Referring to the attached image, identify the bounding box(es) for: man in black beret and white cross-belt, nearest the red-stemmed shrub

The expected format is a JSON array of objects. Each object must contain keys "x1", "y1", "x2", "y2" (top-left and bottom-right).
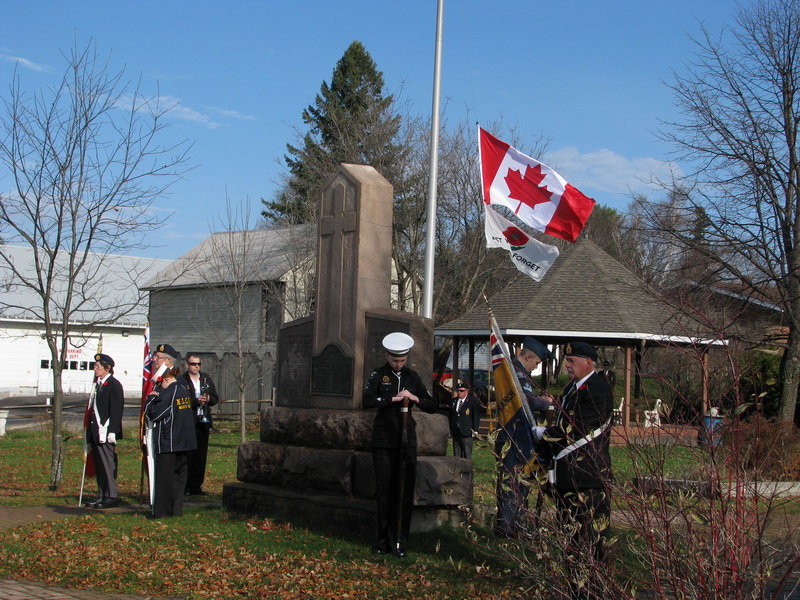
[{"x1": 534, "y1": 342, "x2": 614, "y2": 598}]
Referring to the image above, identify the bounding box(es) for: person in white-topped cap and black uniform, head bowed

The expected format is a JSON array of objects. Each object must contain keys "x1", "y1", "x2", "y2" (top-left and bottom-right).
[{"x1": 362, "y1": 332, "x2": 436, "y2": 558}]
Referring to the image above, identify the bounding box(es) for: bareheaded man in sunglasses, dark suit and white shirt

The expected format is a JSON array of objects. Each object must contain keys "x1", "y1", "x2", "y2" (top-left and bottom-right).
[{"x1": 179, "y1": 352, "x2": 219, "y2": 496}]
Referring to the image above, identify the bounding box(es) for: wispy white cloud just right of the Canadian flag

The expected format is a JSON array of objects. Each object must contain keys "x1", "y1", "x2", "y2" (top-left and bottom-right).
[{"x1": 545, "y1": 146, "x2": 681, "y2": 194}]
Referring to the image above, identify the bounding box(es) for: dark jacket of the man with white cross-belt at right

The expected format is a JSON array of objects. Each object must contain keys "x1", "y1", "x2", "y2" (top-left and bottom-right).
[{"x1": 537, "y1": 373, "x2": 614, "y2": 490}]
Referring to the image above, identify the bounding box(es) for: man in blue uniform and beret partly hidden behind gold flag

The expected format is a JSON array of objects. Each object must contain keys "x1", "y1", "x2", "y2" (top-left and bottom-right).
[{"x1": 494, "y1": 337, "x2": 553, "y2": 537}]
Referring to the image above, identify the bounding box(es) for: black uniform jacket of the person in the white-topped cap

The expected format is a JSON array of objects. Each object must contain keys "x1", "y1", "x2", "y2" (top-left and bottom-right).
[{"x1": 362, "y1": 363, "x2": 436, "y2": 448}]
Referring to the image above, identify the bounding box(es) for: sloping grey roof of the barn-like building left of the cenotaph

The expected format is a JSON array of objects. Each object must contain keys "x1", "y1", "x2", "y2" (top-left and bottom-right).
[{"x1": 142, "y1": 225, "x2": 315, "y2": 291}]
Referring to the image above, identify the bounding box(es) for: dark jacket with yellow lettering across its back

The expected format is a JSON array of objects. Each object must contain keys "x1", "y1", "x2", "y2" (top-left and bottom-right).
[{"x1": 145, "y1": 381, "x2": 197, "y2": 454}]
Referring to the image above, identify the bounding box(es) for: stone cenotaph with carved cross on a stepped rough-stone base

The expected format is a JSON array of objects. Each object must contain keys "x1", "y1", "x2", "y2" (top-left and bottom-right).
[{"x1": 222, "y1": 164, "x2": 473, "y2": 533}]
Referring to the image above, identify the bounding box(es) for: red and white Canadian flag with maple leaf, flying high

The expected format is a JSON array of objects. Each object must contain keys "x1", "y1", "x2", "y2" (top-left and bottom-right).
[{"x1": 478, "y1": 127, "x2": 595, "y2": 242}]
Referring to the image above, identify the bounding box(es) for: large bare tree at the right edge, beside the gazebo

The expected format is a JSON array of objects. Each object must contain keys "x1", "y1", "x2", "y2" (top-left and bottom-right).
[{"x1": 662, "y1": 0, "x2": 800, "y2": 421}]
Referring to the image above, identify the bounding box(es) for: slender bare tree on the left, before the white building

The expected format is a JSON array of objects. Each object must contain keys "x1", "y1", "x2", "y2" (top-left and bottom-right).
[{"x1": 0, "y1": 42, "x2": 188, "y2": 489}]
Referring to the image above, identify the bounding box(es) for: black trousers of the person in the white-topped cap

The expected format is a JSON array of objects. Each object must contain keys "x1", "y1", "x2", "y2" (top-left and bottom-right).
[{"x1": 372, "y1": 448, "x2": 417, "y2": 547}]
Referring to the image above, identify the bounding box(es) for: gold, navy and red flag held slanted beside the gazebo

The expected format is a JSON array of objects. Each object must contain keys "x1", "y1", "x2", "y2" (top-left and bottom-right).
[{"x1": 489, "y1": 312, "x2": 536, "y2": 472}]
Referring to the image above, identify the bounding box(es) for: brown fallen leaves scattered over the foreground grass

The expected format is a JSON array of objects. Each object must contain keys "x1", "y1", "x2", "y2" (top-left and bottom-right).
[{"x1": 0, "y1": 516, "x2": 520, "y2": 600}]
